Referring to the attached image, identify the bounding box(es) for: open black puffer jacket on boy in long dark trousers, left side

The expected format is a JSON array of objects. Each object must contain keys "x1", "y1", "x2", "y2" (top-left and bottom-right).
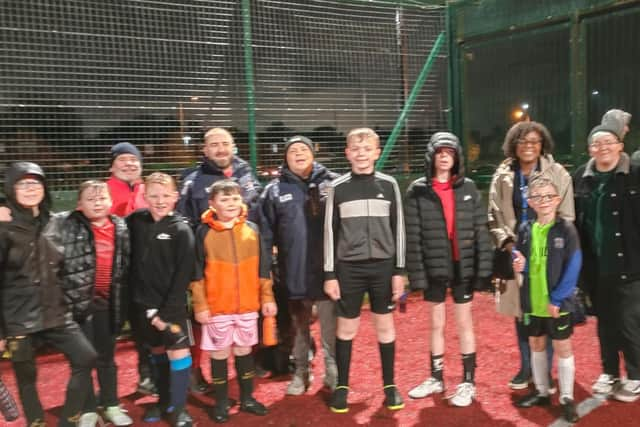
[{"x1": 47, "y1": 211, "x2": 130, "y2": 333}]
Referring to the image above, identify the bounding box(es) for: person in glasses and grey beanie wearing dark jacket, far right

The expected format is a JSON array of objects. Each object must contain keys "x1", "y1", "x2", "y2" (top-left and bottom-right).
[{"x1": 573, "y1": 125, "x2": 640, "y2": 402}]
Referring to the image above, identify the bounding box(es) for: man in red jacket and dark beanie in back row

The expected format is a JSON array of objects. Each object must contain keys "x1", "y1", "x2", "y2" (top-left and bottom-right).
[{"x1": 107, "y1": 142, "x2": 147, "y2": 216}]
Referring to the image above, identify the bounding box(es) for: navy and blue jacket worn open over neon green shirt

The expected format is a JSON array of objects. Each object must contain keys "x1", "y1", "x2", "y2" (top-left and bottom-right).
[{"x1": 517, "y1": 217, "x2": 582, "y2": 313}]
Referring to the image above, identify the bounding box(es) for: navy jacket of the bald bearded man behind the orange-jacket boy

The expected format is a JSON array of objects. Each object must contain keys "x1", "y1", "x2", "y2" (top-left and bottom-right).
[{"x1": 176, "y1": 156, "x2": 262, "y2": 226}]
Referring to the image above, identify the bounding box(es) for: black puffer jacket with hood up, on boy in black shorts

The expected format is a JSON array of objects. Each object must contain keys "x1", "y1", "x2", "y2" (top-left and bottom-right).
[{"x1": 404, "y1": 138, "x2": 493, "y2": 289}]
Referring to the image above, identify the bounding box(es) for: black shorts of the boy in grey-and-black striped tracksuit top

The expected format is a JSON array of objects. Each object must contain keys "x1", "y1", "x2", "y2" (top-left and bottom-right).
[{"x1": 336, "y1": 259, "x2": 395, "y2": 319}]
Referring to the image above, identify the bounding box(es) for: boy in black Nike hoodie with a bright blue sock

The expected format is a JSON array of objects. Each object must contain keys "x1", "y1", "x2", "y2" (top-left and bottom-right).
[{"x1": 127, "y1": 172, "x2": 195, "y2": 427}]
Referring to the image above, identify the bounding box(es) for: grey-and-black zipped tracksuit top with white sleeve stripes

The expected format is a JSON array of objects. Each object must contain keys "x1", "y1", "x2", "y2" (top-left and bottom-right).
[{"x1": 324, "y1": 172, "x2": 405, "y2": 280}]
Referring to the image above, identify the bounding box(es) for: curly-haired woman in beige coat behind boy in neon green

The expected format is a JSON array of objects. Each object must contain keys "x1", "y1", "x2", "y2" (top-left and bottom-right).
[{"x1": 489, "y1": 122, "x2": 575, "y2": 390}]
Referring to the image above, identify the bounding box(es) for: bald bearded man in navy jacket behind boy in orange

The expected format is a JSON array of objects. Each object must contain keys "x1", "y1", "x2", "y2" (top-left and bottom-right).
[{"x1": 177, "y1": 128, "x2": 262, "y2": 227}]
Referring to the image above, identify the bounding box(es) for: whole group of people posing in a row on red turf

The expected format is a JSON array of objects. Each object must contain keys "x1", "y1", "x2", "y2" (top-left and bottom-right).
[{"x1": 0, "y1": 110, "x2": 640, "y2": 427}]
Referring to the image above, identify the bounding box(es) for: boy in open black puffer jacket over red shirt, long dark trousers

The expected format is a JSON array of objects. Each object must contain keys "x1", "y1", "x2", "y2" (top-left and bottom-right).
[{"x1": 55, "y1": 181, "x2": 133, "y2": 426}]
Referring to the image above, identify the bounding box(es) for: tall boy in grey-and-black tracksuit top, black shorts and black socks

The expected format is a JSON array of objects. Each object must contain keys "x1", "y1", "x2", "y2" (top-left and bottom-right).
[{"x1": 324, "y1": 128, "x2": 405, "y2": 413}]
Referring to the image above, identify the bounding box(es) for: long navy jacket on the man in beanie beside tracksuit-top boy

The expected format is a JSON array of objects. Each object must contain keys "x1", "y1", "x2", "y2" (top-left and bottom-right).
[{"x1": 258, "y1": 162, "x2": 338, "y2": 300}]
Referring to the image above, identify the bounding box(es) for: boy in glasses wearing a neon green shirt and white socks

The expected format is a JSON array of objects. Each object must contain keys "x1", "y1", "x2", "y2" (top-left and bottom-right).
[{"x1": 513, "y1": 175, "x2": 582, "y2": 423}]
